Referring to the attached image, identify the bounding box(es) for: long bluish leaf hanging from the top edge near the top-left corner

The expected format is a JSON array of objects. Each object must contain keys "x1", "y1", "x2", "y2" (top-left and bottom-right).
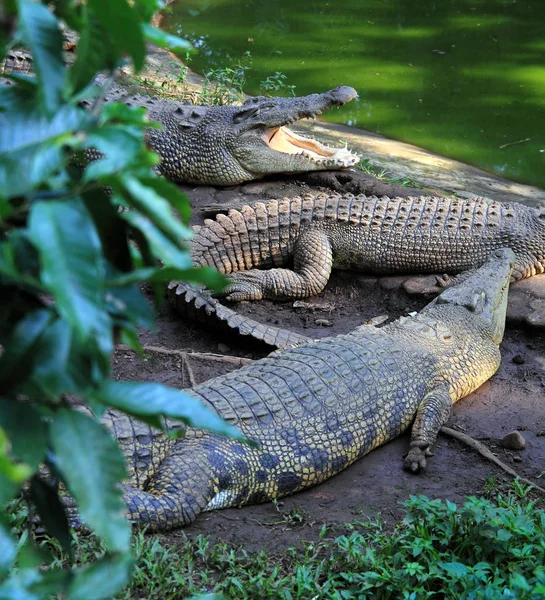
[{"x1": 17, "y1": 0, "x2": 66, "y2": 113}]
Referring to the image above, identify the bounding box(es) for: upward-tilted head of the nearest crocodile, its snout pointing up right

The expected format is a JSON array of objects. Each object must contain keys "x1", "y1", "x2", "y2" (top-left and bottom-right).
[{"x1": 432, "y1": 248, "x2": 516, "y2": 345}]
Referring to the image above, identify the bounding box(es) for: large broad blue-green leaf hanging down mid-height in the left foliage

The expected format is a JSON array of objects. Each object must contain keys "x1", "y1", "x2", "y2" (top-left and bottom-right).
[{"x1": 29, "y1": 198, "x2": 111, "y2": 344}]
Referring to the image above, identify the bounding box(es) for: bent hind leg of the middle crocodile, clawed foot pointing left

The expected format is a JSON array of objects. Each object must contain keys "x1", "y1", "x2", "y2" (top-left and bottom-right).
[{"x1": 223, "y1": 229, "x2": 333, "y2": 301}]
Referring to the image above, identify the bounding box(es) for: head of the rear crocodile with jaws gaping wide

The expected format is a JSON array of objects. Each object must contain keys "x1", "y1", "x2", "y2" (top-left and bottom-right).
[{"x1": 146, "y1": 86, "x2": 359, "y2": 185}]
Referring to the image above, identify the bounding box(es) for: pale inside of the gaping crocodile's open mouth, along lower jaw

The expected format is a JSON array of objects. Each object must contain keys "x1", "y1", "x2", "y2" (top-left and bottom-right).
[{"x1": 263, "y1": 127, "x2": 359, "y2": 167}]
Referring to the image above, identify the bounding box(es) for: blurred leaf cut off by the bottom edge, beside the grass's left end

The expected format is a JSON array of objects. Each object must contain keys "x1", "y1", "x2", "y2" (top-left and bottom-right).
[{"x1": 66, "y1": 555, "x2": 133, "y2": 600}]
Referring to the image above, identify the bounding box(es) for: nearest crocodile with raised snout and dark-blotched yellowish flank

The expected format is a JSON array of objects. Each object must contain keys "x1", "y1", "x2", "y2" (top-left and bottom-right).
[{"x1": 93, "y1": 248, "x2": 516, "y2": 531}]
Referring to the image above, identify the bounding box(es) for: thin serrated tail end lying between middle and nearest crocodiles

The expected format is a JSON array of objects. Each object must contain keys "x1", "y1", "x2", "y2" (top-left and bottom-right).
[{"x1": 167, "y1": 281, "x2": 311, "y2": 348}]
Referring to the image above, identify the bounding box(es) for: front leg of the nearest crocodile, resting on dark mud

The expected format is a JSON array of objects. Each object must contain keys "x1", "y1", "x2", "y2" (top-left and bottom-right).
[{"x1": 404, "y1": 387, "x2": 452, "y2": 473}]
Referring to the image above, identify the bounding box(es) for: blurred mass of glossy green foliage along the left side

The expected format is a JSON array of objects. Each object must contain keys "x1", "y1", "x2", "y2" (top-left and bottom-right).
[{"x1": 0, "y1": 0, "x2": 236, "y2": 600}]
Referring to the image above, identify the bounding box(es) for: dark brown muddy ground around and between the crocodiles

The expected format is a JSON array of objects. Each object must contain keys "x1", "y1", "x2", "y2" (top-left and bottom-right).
[{"x1": 110, "y1": 171, "x2": 545, "y2": 551}]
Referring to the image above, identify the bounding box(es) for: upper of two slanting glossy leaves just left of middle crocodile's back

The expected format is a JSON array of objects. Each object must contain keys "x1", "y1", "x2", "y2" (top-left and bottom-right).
[{"x1": 120, "y1": 175, "x2": 193, "y2": 245}]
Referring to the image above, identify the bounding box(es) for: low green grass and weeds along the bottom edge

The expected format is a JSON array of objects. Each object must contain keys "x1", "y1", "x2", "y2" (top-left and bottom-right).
[{"x1": 5, "y1": 480, "x2": 545, "y2": 600}]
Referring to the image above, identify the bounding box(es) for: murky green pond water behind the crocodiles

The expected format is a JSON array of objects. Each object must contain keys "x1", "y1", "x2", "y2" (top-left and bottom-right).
[{"x1": 164, "y1": 0, "x2": 545, "y2": 187}]
